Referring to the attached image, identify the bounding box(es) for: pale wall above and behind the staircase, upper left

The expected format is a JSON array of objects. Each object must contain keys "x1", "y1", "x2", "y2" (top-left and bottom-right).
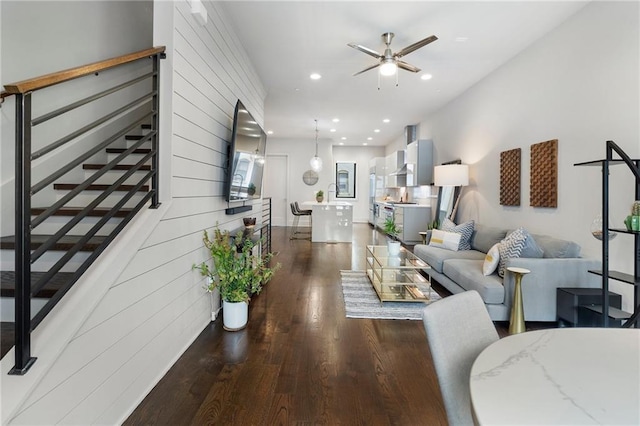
[{"x1": 0, "y1": 0, "x2": 153, "y2": 236}]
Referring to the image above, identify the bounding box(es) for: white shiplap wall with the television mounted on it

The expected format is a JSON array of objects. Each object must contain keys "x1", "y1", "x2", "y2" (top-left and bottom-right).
[{"x1": 6, "y1": 1, "x2": 266, "y2": 424}]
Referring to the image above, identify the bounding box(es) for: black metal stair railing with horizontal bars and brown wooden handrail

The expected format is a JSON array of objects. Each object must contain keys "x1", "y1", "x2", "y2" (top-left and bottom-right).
[{"x1": 0, "y1": 46, "x2": 165, "y2": 375}]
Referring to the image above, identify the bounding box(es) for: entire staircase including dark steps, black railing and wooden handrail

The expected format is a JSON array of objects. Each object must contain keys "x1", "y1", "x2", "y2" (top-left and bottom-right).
[{"x1": 0, "y1": 47, "x2": 164, "y2": 375}]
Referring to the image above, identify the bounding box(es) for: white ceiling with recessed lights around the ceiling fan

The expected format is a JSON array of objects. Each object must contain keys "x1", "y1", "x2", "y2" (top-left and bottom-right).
[{"x1": 223, "y1": 1, "x2": 587, "y2": 146}]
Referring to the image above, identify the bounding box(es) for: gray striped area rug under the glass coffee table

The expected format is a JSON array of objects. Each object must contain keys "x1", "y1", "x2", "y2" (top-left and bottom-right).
[{"x1": 340, "y1": 271, "x2": 441, "y2": 320}]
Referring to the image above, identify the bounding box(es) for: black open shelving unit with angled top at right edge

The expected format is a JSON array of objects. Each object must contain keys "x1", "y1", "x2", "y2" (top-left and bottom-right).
[{"x1": 574, "y1": 141, "x2": 640, "y2": 327}]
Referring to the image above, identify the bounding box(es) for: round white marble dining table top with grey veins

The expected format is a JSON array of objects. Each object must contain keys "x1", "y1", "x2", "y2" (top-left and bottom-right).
[{"x1": 469, "y1": 328, "x2": 640, "y2": 426}]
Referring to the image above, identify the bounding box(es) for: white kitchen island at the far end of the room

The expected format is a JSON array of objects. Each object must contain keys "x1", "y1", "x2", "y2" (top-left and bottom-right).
[{"x1": 302, "y1": 201, "x2": 353, "y2": 243}]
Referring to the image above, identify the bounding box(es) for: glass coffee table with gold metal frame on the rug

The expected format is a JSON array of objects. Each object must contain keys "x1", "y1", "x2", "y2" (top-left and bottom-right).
[{"x1": 366, "y1": 246, "x2": 432, "y2": 302}]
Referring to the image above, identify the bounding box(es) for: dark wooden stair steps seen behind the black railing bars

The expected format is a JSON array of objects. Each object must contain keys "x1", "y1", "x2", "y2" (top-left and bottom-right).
[{"x1": 0, "y1": 124, "x2": 151, "y2": 357}]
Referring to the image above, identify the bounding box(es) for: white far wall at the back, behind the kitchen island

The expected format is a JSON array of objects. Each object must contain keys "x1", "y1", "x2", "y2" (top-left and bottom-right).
[{"x1": 265, "y1": 137, "x2": 384, "y2": 225}]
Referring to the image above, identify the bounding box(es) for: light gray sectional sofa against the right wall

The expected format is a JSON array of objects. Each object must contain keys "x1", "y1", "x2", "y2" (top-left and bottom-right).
[{"x1": 413, "y1": 224, "x2": 602, "y2": 321}]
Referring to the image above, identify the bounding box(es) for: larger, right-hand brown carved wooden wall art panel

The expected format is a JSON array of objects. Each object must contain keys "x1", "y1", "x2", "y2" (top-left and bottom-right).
[{"x1": 529, "y1": 139, "x2": 558, "y2": 207}]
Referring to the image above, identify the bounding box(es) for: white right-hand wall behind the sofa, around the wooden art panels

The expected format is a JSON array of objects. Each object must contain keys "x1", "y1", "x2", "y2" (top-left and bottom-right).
[{"x1": 420, "y1": 2, "x2": 640, "y2": 310}]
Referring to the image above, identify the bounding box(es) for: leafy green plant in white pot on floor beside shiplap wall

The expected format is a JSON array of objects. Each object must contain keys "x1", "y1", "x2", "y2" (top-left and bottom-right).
[{"x1": 193, "y1": 228, "x2": 280, "y2": 331}]
